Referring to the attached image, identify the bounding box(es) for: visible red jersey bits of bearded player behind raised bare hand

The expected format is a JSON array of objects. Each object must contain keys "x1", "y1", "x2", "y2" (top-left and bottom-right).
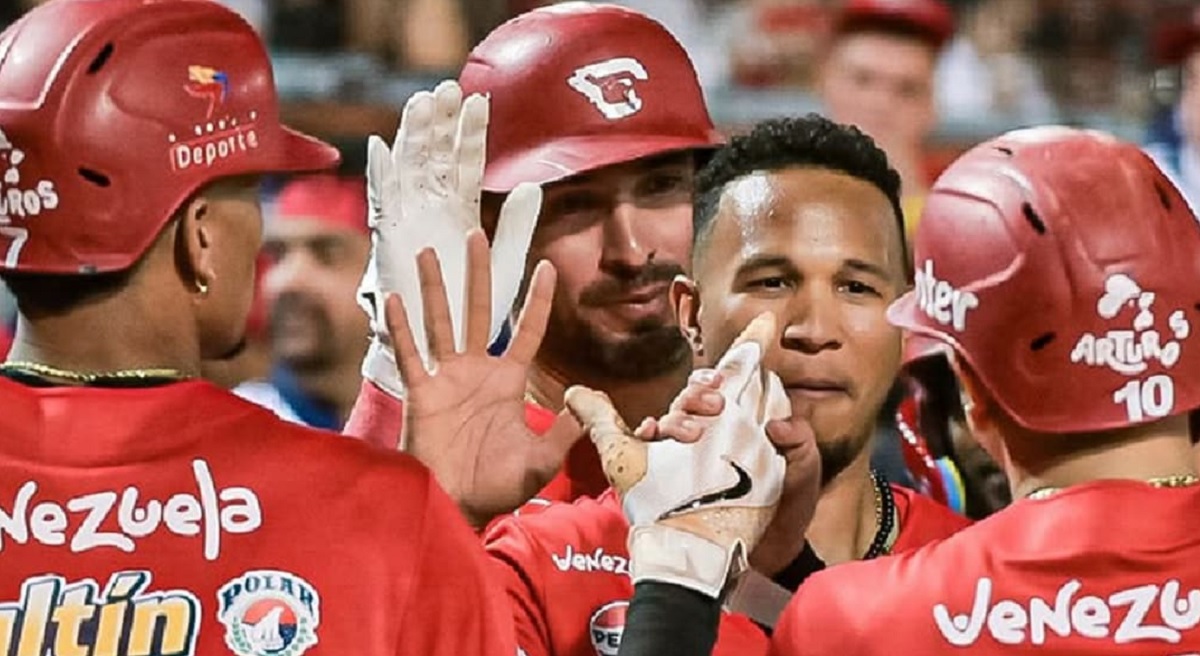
[{"x1": 342, "y1": 380, "x2": 608, "y2": 501}]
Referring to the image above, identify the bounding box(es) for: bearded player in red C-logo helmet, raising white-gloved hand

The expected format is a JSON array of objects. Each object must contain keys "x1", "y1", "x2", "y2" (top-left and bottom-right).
[{"x1": 346, "y1": 2, "x2": 721, "y2": 526}]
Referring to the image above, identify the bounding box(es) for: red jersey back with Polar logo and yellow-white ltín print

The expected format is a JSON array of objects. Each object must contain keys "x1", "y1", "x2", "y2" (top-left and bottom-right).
[{"x1": 0, "y1": 379, "x2": 516, "y2": 656}]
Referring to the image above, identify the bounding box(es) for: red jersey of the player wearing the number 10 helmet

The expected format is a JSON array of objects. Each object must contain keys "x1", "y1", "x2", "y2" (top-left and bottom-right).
[{"x1": 772, "y1": 481, "x2": 1200, "y2": 656}]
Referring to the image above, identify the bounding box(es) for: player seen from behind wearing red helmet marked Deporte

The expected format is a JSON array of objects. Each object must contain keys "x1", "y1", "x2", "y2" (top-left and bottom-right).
[{"x1": 0, "y1": 0, "x2": 516, "y2": 656}]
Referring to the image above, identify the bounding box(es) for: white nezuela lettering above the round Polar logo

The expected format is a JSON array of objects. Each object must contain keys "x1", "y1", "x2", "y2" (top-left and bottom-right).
[{"x1": 0, "y1": 459, "x2": 263, "y2": 560}]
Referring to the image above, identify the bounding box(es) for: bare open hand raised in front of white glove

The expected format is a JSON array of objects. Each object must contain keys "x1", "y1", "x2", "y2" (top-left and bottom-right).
[{"x1": 386, "y1": 230, "x2": 582, "y2": 528}]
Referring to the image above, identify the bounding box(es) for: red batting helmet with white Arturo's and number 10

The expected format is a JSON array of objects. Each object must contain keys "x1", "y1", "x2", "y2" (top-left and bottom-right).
[{"x1": 889, "y1": 127, "x2": 1200, "y2": 433}]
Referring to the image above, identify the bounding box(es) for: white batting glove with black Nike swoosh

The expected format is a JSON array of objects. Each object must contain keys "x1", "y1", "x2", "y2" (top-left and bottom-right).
[{"x1": 566, "y1": 314, "x2": 791, "y2": 598}]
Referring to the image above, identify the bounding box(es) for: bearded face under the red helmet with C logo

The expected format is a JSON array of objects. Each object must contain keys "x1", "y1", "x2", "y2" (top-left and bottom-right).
[{"x1": 527, "y1": 152, "x2": 695, "y2": 380}]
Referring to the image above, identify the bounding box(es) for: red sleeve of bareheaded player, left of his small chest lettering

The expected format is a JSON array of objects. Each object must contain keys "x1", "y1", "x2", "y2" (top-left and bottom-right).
[{"x1": 484, "y1": 522, "x2": 551, "y2": 656}]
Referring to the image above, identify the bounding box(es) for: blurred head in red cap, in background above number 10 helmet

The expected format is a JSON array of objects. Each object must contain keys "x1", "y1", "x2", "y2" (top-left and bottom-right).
[{"x1": 818, "y1": 0, "x2": 954, "y2": 234}]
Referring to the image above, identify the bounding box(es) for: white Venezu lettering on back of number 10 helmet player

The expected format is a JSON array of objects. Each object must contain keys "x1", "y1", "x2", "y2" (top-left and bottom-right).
[{"x1": 934, "y1": 577, "x2": 1200, "y2": 646}]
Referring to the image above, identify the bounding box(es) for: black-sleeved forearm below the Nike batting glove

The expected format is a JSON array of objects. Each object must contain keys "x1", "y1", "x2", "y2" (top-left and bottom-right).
[{"x1": 618, "y1": 580, "x2": 721, "y2": 656}]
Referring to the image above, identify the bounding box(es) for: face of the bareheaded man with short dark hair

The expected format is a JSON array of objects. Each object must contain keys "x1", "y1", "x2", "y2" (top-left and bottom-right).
[{"x1": 678, "y1": 168, "x2": 905, "y2": 480}]
